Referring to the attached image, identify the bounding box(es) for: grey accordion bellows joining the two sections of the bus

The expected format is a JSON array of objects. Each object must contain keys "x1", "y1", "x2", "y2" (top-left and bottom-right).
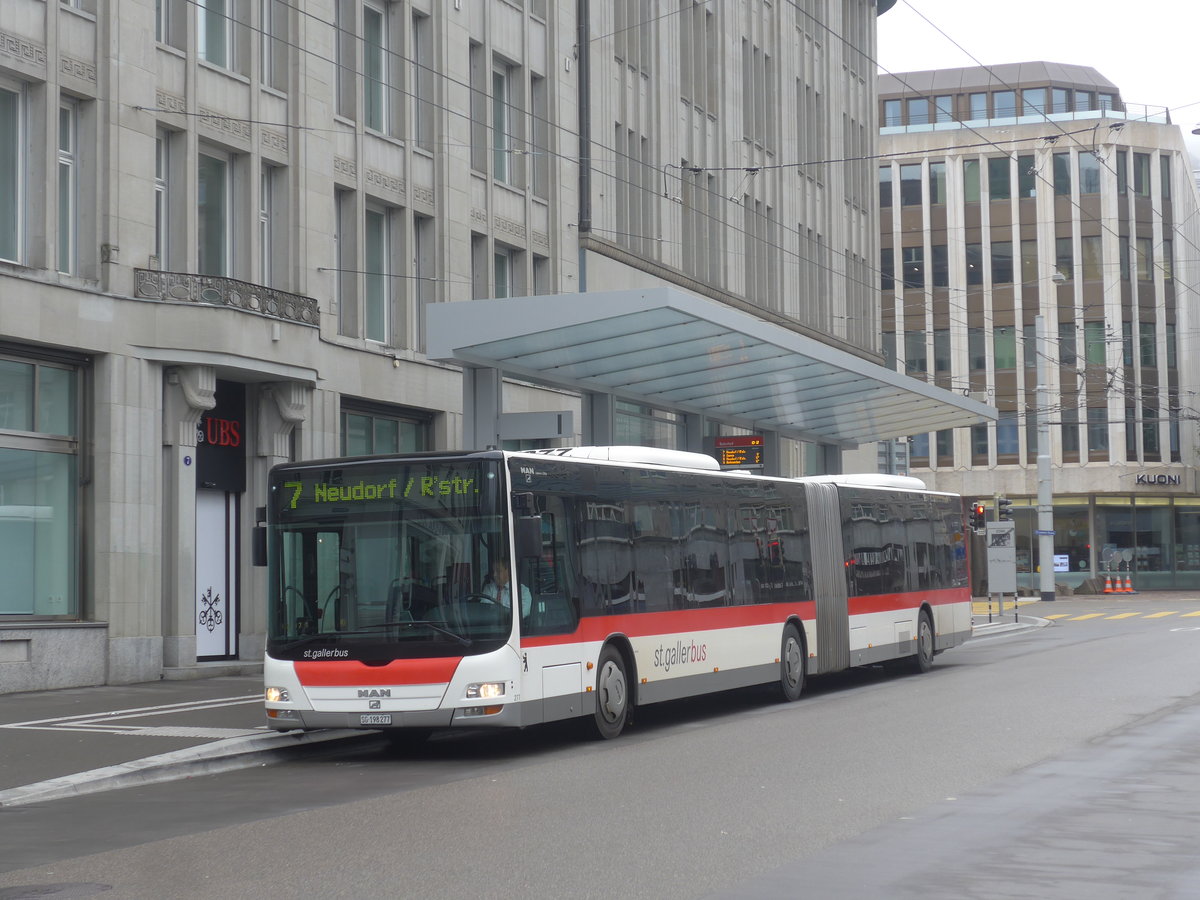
[{"x1": 804, "y1": 481, "x2": 850, "y2": 674}]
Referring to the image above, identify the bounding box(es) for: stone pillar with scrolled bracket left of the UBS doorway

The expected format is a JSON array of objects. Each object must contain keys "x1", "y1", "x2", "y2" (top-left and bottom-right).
[{"x1": 162, "y1": 366, "x2": 217, "y2": 667}]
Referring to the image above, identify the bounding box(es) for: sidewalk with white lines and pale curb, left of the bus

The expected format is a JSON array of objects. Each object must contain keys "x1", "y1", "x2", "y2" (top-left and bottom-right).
[{"x1": 0, "y1": 674, "x2": 362, "y2": 806}]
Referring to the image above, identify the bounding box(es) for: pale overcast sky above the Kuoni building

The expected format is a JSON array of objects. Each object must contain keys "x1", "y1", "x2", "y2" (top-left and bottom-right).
[{"x1": 878, "y1": 0, "x2": 1200, "y2": 166}]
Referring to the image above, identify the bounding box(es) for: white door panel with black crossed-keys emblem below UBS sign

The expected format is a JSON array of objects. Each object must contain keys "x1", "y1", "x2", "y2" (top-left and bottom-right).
[{"x1": 196, "y1": 491, "x2": 239, "y2": 660}]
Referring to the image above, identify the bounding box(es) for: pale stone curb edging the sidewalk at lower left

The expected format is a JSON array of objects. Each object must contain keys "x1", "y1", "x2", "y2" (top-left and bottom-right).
[{"x1": 0, "y1": 728, "x2": 364, "y2": 809}]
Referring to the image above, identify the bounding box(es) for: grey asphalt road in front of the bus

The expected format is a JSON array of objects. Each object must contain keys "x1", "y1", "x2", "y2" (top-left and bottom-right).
[{"x1": 0, "y1": 600, "x2": 1200, "y2": 900}]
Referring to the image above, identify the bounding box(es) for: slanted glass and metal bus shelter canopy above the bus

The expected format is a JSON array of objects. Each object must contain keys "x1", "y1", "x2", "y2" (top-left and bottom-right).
[{"x1": 426, "y1": 287, "x2": 996, "y2": 446}]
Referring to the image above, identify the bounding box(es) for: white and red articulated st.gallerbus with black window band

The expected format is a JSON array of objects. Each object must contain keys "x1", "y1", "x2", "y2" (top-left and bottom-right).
[{"x1": 264, "y1": 448, "x2": 971, "y2": 738}]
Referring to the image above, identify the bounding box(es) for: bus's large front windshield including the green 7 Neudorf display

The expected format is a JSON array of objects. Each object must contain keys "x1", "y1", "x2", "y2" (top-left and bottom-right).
[{"x1": 268, "y1": 458, "x2": 512, "y2": 661}]
